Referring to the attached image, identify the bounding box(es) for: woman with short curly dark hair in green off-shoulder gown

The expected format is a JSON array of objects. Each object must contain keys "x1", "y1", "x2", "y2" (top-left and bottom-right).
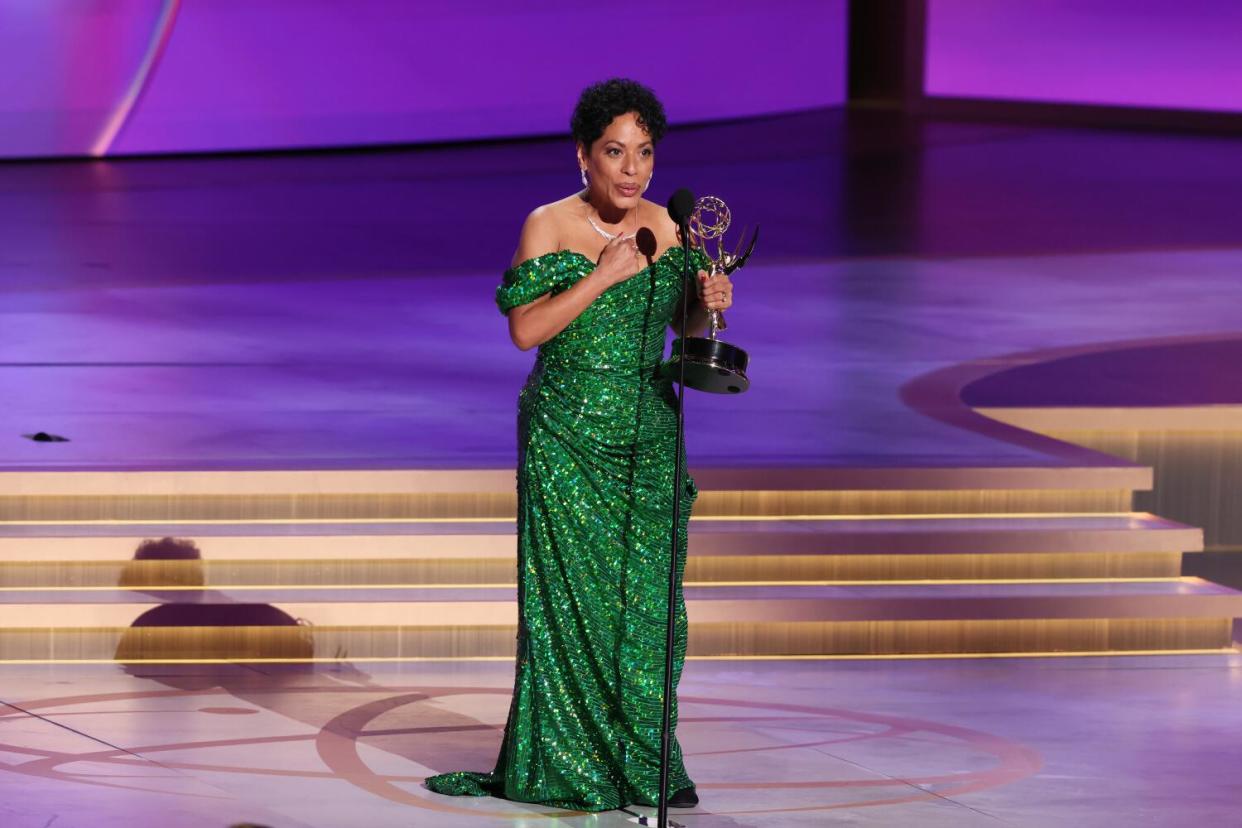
[{"x1": 426, "y1": 74, "x2": 733, "y2": 811}]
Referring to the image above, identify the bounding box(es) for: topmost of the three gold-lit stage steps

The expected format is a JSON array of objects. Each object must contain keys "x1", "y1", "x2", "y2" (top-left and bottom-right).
[{"x1": 0, "y1": 466, "x2": 1151, "y2": 524}]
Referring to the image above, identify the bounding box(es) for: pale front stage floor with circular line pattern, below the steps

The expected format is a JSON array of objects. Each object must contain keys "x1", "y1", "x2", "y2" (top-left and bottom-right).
[{"x1": 0, "y1": 655, "x2": 1242, "y2": 828}]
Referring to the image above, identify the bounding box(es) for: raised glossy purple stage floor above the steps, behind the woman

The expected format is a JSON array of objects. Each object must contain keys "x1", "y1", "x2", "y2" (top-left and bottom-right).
[{"x1": 7, "y1": 110, "x2": 1242, "y2": 470}]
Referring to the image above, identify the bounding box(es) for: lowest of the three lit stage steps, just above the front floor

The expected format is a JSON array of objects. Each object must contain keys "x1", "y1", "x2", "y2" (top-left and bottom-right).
[{"x1": 0, "y1": 578, "x2": 1242, "y2": 660}]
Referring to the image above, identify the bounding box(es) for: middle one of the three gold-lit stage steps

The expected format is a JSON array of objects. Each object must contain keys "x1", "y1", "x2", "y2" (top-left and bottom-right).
[{"x1": 0, "y1": 514, "x2": 1202, "y2": 588}]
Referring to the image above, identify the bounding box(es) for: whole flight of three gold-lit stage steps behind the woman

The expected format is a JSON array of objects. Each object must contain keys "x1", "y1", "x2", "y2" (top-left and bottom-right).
[{"x1": 0, "y1": 468, "x2": 1242, "y2": 662}]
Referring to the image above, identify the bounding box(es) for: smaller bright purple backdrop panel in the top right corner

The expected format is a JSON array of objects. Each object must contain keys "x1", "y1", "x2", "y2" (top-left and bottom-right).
[{"x1": 924, "y1": 0, "x2": 1242, "y2": 112}]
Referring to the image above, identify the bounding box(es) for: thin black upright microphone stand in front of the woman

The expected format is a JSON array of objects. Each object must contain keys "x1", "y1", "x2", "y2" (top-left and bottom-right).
[{"x1": 638, "y1": 196, "x2": 693, "y2": 828}]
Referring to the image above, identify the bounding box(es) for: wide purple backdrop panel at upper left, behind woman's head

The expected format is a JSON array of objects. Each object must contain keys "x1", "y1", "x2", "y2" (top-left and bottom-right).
[{"x1": 0, "y1": 0, "x2": 846, "y2": 158}]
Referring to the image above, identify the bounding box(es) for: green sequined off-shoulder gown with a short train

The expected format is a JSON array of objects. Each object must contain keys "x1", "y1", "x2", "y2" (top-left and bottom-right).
[{"x1": 426, "y1": 247, "x2": 705, "y2": 811}]
